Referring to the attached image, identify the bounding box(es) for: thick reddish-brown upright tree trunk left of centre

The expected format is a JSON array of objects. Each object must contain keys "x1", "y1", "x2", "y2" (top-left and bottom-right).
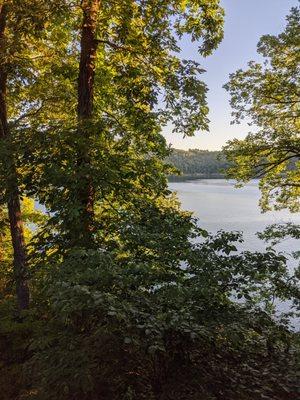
[{"x1": 77, "y1": 0, "x2": 100, "y2": 245}]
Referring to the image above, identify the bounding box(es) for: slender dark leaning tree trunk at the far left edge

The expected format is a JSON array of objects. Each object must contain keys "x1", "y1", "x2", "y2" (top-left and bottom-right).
[{"x1": 0, "y1": 4, "x2": 29, "y2": 310}]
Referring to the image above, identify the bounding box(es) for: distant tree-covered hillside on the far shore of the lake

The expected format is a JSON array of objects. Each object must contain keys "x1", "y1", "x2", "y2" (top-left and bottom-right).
[{"x1": 168, "y1": 149, "x2": 229, "y2": 180}]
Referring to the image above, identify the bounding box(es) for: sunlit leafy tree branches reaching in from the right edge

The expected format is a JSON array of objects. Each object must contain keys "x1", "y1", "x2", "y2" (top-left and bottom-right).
[{"x1": 224, "y1": 7, "x2": 300, "y2": 212}]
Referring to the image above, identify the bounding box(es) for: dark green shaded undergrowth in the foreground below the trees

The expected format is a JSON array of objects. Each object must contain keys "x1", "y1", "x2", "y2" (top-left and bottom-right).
[{"x1": 26, "y1": 231, "x2": 299, "y2": 400}]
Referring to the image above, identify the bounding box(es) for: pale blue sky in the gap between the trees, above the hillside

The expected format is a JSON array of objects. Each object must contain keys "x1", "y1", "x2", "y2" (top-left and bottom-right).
[{"x1": 164, "y1": 0, "x2": 299, "y2": 150}]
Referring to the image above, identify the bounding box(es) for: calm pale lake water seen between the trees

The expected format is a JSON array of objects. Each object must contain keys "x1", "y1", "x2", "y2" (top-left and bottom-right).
[{"x1": 169, "y1": 179, "x2": 300, "y2": 252}]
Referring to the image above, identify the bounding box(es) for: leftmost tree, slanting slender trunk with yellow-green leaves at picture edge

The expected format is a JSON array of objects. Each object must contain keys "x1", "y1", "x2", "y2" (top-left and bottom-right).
[{"x1": 0, "y1": 0, "x2": 69, "y2": 310}]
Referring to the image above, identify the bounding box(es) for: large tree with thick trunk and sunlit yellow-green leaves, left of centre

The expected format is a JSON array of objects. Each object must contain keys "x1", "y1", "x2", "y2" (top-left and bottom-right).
[{"x1": 20, "y1": 0, "x2": 223, "y2": 249}]
